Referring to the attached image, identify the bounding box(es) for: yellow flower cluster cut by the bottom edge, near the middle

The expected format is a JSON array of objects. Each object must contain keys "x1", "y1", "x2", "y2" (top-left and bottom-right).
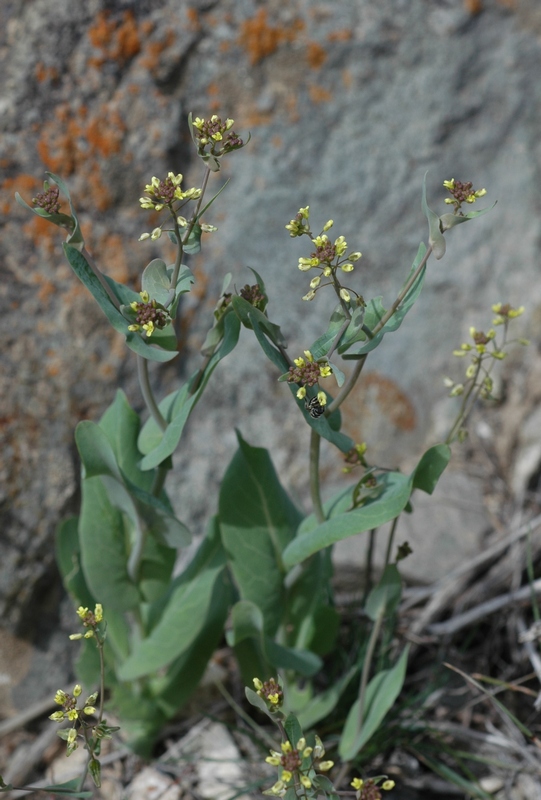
[{"x1": 263, "y1": 736, "x2": 334, "y2": 797}]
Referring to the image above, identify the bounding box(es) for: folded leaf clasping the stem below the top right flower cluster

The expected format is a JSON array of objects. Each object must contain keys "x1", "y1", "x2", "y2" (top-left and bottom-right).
[{"x1": 338, "y1": 242, "x2": 426, "y2": 359}]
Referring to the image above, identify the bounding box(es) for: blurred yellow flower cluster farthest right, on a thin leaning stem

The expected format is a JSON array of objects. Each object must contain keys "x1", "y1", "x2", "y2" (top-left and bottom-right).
[{"x1": 444, "y1": 303, "x2": 528, "y2": 400}]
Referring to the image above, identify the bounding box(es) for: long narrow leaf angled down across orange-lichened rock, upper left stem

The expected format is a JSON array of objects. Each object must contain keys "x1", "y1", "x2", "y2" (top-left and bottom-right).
[{"x1": 64, "y1": 244, "x2": 176, "y2": 362}]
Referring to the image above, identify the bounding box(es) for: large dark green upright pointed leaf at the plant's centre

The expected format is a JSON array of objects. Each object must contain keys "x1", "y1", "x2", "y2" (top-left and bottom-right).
[{"x1": 219, "y1": 433, "x2": 302, "y2": 635}]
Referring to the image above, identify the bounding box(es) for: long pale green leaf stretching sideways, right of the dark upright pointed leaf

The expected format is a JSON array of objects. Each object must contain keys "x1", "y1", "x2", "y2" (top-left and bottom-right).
[{"x1": 283, "y1": 472, "x2": 412, "y2": 569}]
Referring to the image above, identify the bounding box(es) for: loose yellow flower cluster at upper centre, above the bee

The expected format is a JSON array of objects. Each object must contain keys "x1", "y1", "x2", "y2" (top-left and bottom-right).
[{"x1": 286, "y1": 206, "x2": 362, "y2": 303}]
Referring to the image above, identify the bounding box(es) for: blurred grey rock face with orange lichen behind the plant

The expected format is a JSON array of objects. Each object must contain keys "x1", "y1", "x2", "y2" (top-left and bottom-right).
[{"x1": 0, "y1": 0, "x2": 541, "y2": 713}]
